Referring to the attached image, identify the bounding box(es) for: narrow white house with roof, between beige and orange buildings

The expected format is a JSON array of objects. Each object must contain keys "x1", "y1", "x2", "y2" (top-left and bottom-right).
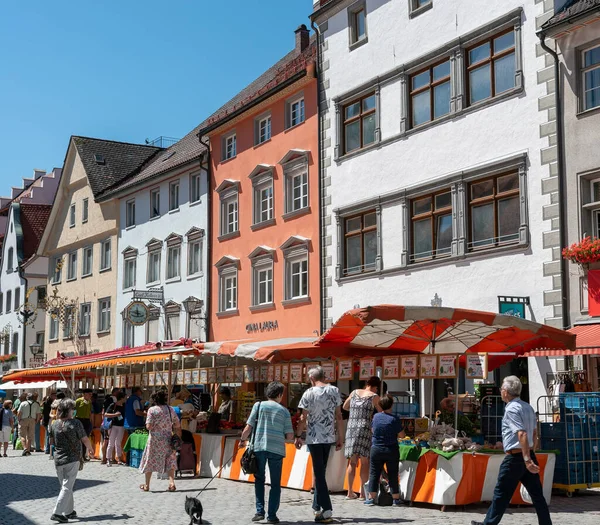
[{"x1": 106, "y1": 134, "x2": 208, "y2": 347}]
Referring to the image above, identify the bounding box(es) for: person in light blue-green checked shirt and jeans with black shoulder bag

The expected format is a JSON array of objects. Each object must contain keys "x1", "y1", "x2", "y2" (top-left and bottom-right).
[{"x1": 240, "y1": 381, "x2": 294, "y2": 523}]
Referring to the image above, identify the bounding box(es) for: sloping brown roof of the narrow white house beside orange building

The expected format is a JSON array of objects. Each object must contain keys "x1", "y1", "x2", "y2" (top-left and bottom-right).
[{"x1": 97, "y1": 123, "x2": 206, "y2": 202}]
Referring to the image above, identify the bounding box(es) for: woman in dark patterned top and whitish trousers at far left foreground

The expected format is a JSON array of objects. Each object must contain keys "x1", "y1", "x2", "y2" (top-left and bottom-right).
[{"x1": 50, "y1": 399, "x2": 94, "y2": 523}]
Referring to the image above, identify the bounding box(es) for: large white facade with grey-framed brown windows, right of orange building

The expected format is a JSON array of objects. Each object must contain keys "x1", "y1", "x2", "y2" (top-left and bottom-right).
[{"x1": 312, "y1": 0, "x2": 561, "y2": 406}]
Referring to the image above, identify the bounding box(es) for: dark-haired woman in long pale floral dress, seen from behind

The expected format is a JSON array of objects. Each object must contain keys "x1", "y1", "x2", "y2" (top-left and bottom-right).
[{"x1": 140, "y1": 391, "x2": 181, "y2": 492}]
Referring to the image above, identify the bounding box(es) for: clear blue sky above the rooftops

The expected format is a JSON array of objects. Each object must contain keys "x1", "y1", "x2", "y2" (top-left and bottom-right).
[{"x1": 0, "y1": 0, "x2": 312, "y2": 195}]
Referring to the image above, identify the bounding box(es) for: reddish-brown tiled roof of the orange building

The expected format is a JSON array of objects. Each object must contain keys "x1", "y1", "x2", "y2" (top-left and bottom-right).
[{"x1": 199, "y1": 34, "x2": 317, "y2": 135}]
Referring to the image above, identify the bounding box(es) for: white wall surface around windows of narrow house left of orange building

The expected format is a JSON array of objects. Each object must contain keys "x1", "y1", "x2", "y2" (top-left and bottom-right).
[{"x1": 116, "y1": 167, "x2": 208, "y2": 346}]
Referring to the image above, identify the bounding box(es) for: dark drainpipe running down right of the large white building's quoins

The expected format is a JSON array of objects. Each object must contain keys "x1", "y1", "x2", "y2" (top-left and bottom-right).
[{"x1": 538, "y1": 32, "x2": 571, "y2": 330}]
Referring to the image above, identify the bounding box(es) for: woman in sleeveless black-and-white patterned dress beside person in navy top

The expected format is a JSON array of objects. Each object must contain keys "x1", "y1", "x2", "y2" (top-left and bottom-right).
[{"x1": 344, "y1": 376, "x2": 381, "y2": 500}]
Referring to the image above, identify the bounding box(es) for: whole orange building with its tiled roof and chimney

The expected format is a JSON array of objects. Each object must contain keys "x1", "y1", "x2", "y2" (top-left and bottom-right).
[{"x1": 200, "y1": 27, "x2": 321, "y2": 341}]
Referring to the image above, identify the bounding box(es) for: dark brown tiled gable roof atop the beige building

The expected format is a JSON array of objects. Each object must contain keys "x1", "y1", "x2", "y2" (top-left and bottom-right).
[{"x1": 72, "y1": 136, "x2": 163, "y2": 200}]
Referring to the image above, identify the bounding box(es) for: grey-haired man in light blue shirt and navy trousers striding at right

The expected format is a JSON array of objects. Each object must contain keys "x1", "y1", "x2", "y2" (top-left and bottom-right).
[{"x1": 471, "y1": 376, "x2": 552, "y2": 525}]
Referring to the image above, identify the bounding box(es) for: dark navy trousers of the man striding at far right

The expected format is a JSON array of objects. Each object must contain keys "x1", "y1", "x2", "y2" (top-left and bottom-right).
[{"x1": 483, "y1": 451, "x2": 552, "y2": 525}]
